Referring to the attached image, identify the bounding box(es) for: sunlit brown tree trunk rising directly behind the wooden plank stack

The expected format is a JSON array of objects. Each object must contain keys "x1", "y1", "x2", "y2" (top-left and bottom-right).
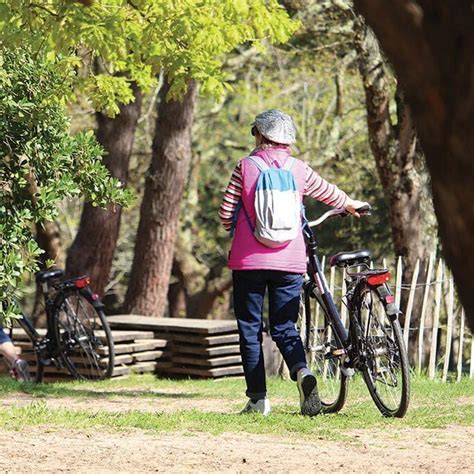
[{"x1": 125, "y1": 80, "x2": 197, "y2": 317}]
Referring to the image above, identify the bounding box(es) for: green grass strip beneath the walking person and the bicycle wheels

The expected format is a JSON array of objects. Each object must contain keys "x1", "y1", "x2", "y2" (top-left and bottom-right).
[{"x1": 0, "y1": 375, "x2": 474, "y2": 440}]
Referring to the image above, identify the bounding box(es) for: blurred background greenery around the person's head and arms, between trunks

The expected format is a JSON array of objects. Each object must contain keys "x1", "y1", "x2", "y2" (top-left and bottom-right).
[{"x1": 191, "y1": 44, "x2": 391, "y2": 274}]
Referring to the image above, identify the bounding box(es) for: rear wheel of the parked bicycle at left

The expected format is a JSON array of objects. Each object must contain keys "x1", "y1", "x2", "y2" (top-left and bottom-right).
[{"x1": 55, "y1": 290, "x2": 114, "y2": 380}]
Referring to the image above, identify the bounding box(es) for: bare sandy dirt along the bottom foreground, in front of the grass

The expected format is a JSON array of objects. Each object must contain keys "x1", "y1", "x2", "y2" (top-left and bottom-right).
[{"x1": 0, "y1": 427, "x2": 474, "y2": 473}]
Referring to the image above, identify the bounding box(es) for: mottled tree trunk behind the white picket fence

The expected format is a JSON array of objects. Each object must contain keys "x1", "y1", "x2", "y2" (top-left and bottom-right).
[{"x1": 355, "y1": 21, "x2": 436, "y2": 362}]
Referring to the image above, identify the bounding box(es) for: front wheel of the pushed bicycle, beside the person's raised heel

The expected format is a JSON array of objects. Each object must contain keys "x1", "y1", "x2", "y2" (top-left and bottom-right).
[{"x1": 301, "y1": 290, "x2": 348, "y2": 413}]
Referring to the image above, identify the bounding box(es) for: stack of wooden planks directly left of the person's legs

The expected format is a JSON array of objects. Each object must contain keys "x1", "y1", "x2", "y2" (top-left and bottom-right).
[{"x1": 108, "y1": 315, "x2": 243, "y2": 378}]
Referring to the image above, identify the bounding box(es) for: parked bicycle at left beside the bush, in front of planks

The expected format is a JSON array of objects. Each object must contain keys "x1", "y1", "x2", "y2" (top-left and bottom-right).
[{"x1": 17, "y1": 270, "x2": 115, "y2": 383}]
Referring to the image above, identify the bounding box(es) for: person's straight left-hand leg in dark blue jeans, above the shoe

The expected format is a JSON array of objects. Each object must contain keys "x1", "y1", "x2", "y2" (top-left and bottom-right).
[{"x1": 232, "y1": 270, "x2": 267, "y2": 400}]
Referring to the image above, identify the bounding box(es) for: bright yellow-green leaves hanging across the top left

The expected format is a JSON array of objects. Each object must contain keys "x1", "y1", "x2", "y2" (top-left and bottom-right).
[{"x1": 0, "y1": 0, "x2": 299, "y2": 116}]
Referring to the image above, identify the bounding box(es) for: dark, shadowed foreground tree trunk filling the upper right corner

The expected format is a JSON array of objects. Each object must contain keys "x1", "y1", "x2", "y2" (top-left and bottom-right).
[{"x1": 354, "y1": 0, "x2": 474, "y2": 331}]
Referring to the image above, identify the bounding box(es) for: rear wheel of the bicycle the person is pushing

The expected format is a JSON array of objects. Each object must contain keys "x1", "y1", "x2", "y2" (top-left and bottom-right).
[{"x1": 359, "y1": 288, "x2": 410, "y2": 418}]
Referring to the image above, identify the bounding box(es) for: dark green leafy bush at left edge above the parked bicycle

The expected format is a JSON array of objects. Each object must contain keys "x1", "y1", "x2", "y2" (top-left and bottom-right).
[{"x1": 0, "y1": 48, "x2": 131, "y2": 320}]
